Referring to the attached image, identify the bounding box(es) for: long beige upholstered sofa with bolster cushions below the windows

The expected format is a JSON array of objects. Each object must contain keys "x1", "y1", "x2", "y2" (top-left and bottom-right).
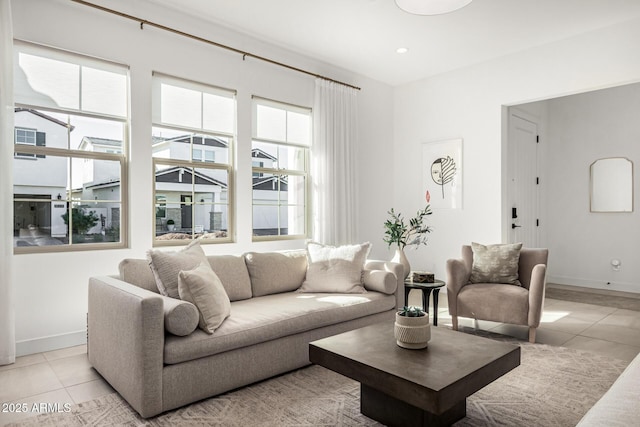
[{"x1": 88, "y1": 251, "x2": 404, "y2": 418}]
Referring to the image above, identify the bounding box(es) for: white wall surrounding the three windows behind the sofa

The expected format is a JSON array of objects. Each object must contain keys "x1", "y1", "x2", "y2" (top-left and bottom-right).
[{"x1": 12, "y1": 0, "x2": 393, "y2": 354}]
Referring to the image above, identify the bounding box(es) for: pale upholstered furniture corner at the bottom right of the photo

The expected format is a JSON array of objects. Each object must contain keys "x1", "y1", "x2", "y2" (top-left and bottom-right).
[{"x1": 578, "y1": 355, "x2": 640, "y2": 427}]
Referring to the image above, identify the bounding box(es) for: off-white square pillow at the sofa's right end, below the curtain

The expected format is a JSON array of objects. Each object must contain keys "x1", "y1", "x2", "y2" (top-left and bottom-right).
[{"x1": 298, "y1": 242, "x2": 371, "y2": 294}]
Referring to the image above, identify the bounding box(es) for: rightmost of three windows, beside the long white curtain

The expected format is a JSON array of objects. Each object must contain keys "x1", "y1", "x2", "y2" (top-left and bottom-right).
[{"x1": 251, "y1": 97, "x2": 311, "y2": 240}]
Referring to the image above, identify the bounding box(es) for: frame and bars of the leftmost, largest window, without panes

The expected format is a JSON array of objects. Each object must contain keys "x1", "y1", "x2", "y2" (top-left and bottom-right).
[{"x1": 13, "y1": 40, "x2": 131, "y2": 254}]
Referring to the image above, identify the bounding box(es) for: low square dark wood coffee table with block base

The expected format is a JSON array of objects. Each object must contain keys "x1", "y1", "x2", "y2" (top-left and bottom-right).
[{"x1": 309, "y1": 322, "x2": 520, "y2": 426}]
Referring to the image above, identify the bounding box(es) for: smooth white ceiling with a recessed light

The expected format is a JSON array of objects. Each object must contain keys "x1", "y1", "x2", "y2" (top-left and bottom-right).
[{"x1": 149, "y1": 0, "x2": 640, "y2": 86}]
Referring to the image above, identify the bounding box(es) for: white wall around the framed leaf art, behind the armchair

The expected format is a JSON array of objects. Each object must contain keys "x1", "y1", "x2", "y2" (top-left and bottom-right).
[{"x1": 388, "y1": 15, "x2": 640, "y2": 280}]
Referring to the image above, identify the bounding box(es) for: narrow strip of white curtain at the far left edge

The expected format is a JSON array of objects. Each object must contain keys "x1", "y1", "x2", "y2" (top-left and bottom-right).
[{"x1": 0, "y1": 0, "x2": 16, "y2": 365}]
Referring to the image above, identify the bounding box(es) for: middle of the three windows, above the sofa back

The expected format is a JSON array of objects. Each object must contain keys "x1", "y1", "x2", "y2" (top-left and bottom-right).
[{"x1": 152, "y1": 73, "x2": 236, "y2": 245}]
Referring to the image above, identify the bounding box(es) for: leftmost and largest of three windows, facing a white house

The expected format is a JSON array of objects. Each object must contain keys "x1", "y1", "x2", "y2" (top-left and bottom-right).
[{"x1": 13, "y1": 42, "x2": 128, "y2": 253}]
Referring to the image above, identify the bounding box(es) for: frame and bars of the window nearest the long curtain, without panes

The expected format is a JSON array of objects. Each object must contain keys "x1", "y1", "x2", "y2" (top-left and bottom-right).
[{"x1": 251, "y1": 95, "x2": 313, "y2": 242}]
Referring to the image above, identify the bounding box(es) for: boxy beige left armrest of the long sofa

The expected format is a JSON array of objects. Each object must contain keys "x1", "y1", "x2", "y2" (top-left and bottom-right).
[{"x1": 87, "y1": 276, "x2": 164, "y2": 418}]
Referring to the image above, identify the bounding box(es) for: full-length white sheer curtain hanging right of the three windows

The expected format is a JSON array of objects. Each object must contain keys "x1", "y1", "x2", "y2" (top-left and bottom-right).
[{"x1": 311, "y1": 79, "x2": 358, "y2": 245}]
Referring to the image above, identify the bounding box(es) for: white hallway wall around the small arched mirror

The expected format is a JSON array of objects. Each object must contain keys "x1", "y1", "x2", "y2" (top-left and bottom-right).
[{"x1": 546, "y1": 84, "x2": 640, "y2": 292}]
